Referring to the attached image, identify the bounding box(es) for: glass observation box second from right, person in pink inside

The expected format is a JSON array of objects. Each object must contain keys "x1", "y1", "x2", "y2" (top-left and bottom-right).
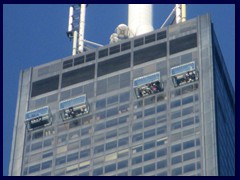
[{"x1": 133, "y1": 72, "x2": 164, "y2": 98}]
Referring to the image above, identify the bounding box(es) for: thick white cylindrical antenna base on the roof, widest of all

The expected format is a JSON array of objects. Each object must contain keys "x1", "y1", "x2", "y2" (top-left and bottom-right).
[{"x1": 128, "y1": 4, "x2": 153, "y2": 37}]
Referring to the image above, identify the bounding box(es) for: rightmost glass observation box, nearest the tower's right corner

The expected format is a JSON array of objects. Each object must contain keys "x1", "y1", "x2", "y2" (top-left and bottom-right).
[{"x1": 171, "y1": 62, "x2": 199, "y2": 87}]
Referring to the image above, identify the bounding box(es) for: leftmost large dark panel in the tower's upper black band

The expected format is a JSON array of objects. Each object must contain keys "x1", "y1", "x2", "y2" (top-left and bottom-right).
[{"x1": 31, "y1": 75, "x2": 59, "y2": 97}]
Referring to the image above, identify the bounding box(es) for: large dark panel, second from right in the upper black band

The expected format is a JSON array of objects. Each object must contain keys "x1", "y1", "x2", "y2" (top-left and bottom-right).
[{"x1": 133, "y1": 43, "x2": 167, "y2": 65}]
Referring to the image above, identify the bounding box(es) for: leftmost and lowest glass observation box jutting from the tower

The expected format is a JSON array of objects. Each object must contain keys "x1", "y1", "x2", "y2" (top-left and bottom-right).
[{"x1": 25, "y1": 106, "x2": 52, "y2": 131}]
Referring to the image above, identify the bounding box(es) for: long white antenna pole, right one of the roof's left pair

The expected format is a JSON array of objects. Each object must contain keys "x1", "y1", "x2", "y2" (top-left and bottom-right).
[{"x1": 78, "y1": 4, "x2": 87, "y2": 53}]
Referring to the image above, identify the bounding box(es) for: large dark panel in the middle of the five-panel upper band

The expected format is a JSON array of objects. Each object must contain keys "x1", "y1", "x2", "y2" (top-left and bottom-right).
[{"x1": 98, "y1": 53, "x2": 131, "y2": 77}]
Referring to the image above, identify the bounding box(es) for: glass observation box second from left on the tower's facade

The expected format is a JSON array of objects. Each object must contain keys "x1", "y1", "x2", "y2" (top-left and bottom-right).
[{"x1": 59, "y1": 95, "x2": 89, "y2": 121}]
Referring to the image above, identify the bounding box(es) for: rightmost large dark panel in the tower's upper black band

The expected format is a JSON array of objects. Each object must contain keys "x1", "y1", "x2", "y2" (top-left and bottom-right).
[{"x1": 170, "y1": 33, "x2": 197, "y2": 54}]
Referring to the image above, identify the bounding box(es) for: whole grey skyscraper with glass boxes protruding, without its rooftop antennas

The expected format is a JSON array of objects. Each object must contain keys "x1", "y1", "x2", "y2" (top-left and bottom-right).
[{"x1": 9, "y1": 15, "x2": 235, "y2": 176}]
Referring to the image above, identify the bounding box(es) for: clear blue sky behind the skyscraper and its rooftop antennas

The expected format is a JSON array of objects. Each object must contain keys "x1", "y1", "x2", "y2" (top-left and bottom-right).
[{"x1": 3, "y1": 4, "x2": 235, "y2": 175}]
